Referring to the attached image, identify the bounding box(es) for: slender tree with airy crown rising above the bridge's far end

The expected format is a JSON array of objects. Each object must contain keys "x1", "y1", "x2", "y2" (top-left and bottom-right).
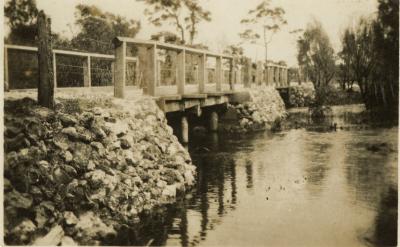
[{"x1": 239, "y1": 0, "x2": 287, "y2": 61}]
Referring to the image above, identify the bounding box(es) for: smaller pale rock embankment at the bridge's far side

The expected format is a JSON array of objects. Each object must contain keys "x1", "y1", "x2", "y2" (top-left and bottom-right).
[{"x1": 222, "y1": 86, "x2": 286, "y2": 133}]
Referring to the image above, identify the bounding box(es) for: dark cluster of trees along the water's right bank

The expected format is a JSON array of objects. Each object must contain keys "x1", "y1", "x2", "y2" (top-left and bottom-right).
[{"x1": 297, "y1": 0, "x2": 399, "y2": 114}]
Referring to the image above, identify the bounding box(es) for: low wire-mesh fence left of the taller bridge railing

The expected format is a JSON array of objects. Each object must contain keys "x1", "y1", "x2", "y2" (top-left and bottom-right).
[{"x1": 4, "y1": 45, "x2": 138, "y2": 89}]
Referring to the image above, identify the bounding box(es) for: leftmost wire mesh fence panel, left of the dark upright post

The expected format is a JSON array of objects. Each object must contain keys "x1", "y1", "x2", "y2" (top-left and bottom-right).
[{"x1": 8, "y1": 49, "x2": 39, "y2": 89}]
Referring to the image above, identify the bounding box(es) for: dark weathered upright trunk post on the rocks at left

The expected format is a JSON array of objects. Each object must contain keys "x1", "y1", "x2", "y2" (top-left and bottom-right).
[{"x1": 37, "y1": 10, "x2": 54, "y2": 108}]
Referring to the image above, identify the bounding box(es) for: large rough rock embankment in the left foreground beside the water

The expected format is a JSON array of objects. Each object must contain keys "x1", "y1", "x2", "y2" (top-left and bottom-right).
[{"x1": 4, "y1": 95, "x2": 195, "y2": 245}]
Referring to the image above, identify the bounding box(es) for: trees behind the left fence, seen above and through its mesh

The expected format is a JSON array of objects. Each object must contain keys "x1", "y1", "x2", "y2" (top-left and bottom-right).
[{"x1": 4, "y1": 0, "x2": 211, "y2": 89}]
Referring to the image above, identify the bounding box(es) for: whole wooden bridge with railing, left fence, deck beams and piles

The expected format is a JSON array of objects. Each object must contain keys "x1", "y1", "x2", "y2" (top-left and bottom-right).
[{"x1": 4, "y1": 37, "x2": 289, "y2": 141}]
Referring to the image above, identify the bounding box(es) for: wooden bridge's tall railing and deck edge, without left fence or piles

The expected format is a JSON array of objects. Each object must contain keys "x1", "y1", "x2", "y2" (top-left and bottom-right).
[{"x1": 114, "y1": 37, "x2": 288, "y2": 112}]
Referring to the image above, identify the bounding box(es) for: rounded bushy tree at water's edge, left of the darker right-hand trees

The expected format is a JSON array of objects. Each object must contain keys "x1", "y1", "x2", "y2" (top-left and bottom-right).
[{"x1": 297, "y1": 21, "x2": 335, "y2": 105}]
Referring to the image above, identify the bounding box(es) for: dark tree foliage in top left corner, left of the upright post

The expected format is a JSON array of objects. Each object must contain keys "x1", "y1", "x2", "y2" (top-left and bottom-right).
[{"x1": 4, "y1": 0, "x2": 38, "y2": 45}]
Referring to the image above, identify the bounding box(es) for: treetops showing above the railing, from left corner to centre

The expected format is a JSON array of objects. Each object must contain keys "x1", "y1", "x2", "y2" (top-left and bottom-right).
[{"x1": 4, "y1": 0, "x2": 211, "y2": 53}]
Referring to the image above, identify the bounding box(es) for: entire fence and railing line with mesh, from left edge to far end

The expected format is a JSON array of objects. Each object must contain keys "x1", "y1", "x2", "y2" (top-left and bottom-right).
[{"x1": 4, "y1": 41, "x2": 288, "y2": 95}]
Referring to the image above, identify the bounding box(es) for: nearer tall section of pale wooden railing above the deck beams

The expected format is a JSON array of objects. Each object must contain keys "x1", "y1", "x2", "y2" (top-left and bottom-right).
[{"x1": 114, "y1": 37, "x2": 238, "y2": 97}]
